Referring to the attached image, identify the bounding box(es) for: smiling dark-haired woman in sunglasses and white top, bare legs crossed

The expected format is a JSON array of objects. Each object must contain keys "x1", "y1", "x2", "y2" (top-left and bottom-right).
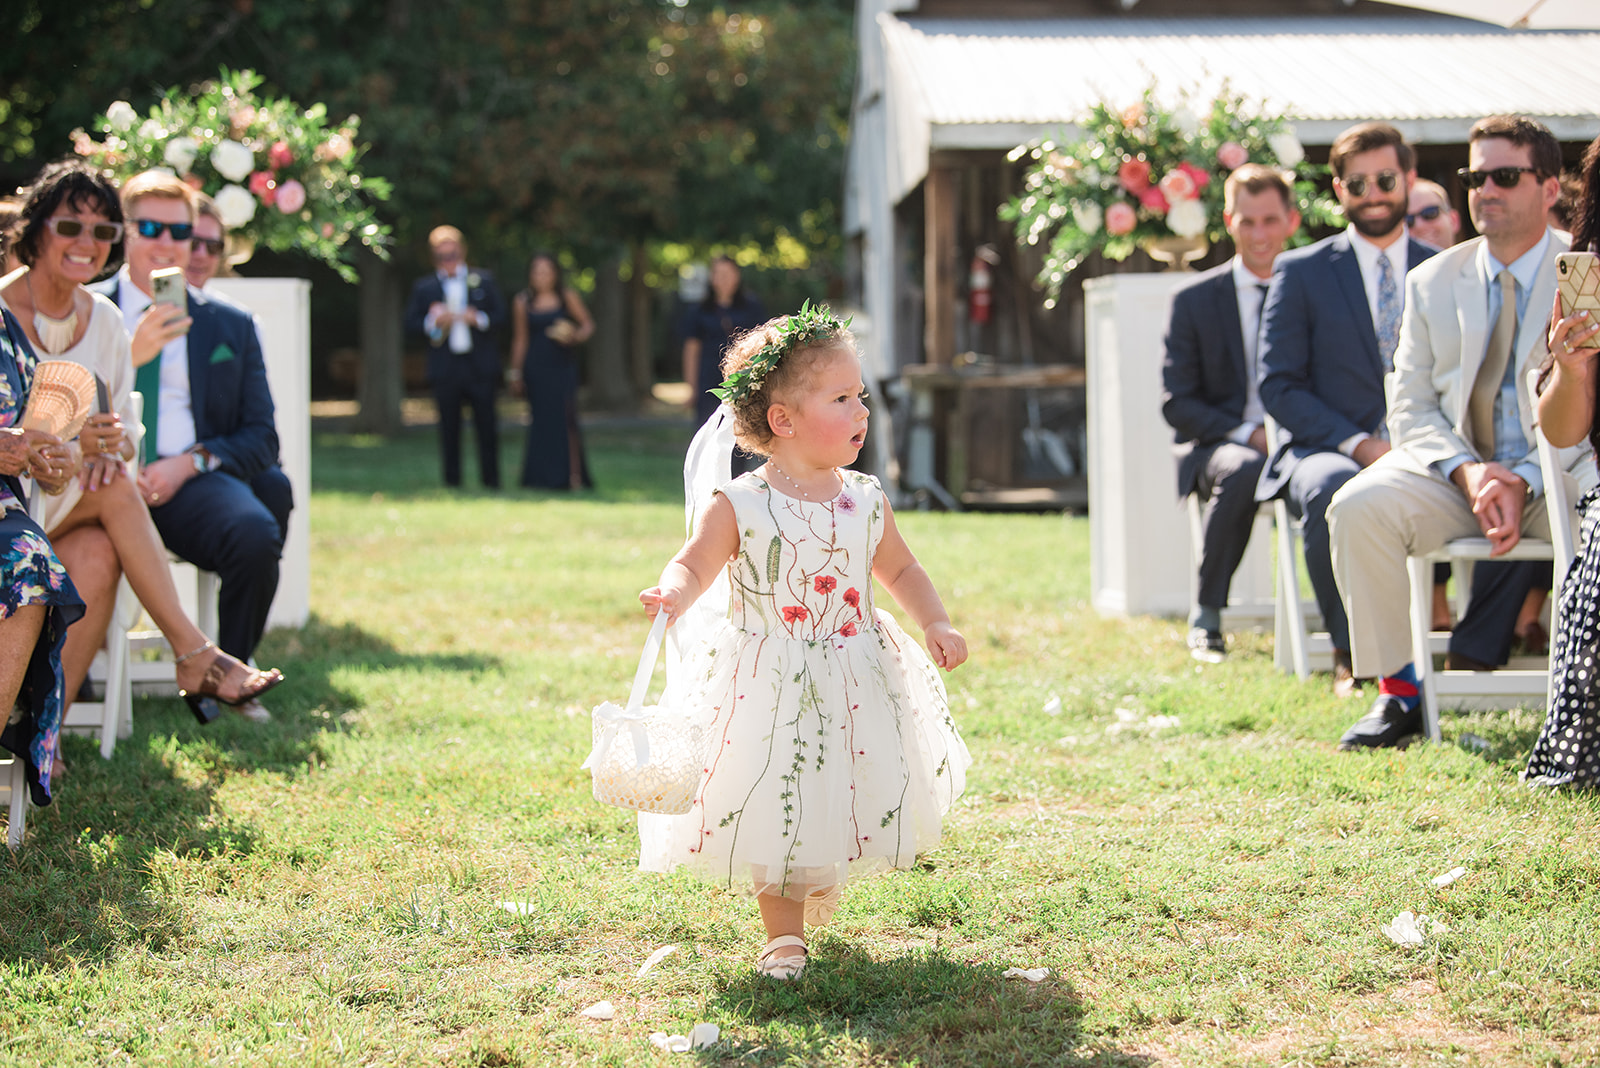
[{"x1": 0, "y1": 161, "x2": 283, "y2": 723}]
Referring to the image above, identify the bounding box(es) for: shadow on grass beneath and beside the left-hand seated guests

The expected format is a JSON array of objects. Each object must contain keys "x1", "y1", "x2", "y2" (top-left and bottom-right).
[{"x1": 0, "y1": 607, "x2": 499, "y2": 969}]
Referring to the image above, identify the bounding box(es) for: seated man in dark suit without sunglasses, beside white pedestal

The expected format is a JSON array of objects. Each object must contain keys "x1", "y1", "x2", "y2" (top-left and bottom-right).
[{"x1": 1162, "y1": 163, "x2": 1299, "y2": 662}]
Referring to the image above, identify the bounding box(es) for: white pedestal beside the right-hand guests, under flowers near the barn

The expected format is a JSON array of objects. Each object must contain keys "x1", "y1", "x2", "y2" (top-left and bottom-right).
[{"x1": 1083, "y1": 272, "x2": 1272, "y2": 617}]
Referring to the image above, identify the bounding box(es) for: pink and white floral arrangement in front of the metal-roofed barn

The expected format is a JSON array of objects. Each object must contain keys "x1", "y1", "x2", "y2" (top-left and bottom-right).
[{"x1": 1000, "y1": 83, "x2": 1344, "y2": 300}]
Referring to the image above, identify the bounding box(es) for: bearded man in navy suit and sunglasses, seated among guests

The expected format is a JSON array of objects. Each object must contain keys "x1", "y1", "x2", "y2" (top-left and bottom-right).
[{"x1": 1256, "y1": 123, "x2": 1437, "y2": 695}]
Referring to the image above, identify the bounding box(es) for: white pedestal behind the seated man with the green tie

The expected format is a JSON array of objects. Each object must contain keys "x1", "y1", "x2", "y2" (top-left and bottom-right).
[{"x1": 206, "y1": 278, "x2": 310, "y2": 628}]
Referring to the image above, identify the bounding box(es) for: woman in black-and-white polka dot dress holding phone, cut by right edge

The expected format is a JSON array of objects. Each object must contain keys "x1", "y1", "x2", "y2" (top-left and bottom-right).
[{"x1": 1523, "y1": 139, "x2": 1600, "y2": 787}]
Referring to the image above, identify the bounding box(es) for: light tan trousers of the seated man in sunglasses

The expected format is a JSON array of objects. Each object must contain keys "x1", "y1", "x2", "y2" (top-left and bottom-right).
[{"x1": 1328, "y1": 451, "x2": 1550, "y2": 678}]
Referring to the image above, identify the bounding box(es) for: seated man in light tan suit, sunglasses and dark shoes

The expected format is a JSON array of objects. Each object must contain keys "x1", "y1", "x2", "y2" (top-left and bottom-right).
[{"x1": 1328, "y1": 115, "x2": 1578, "y2": 750}]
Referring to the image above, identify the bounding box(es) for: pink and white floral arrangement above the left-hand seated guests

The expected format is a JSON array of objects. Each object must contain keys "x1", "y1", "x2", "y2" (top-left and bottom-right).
[{"x1": 72, "y1": 67, "x2": 390, "y2": 281}]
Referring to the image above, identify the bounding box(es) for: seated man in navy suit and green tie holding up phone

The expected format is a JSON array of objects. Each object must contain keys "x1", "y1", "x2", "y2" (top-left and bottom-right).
[{"x1": 96, "y1": 171, "x2": 293, "y2": 723}]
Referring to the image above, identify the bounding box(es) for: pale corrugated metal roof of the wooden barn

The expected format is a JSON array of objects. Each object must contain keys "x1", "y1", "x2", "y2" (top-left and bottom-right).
[{"x1": 878, "y1": 14, "x2": 1600, "y2": 133}]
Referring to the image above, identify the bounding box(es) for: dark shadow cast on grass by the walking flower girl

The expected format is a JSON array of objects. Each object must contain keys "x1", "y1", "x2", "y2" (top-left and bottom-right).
[{"x1": 706, "y1": 938, "x2": 1152, "y2": 1068}]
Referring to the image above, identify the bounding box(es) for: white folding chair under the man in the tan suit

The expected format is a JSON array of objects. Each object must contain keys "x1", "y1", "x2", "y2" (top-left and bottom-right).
[{"x1": 1406, "y1": 428, "x2": 1578, "y2": 742}]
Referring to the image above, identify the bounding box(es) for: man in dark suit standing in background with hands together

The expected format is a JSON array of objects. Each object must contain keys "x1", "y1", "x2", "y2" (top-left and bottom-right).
[{"x1": 405, "y1": 225, "x2": 506, "y2": 489}]
